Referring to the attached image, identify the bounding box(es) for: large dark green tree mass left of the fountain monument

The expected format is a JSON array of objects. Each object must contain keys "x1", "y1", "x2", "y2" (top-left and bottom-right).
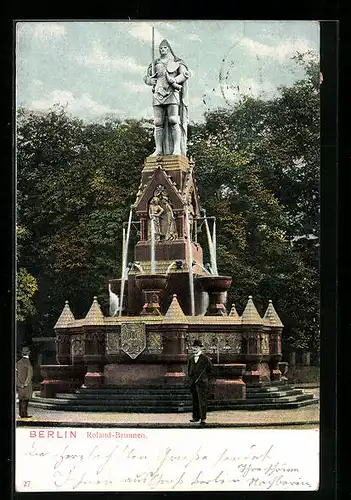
[{"x1": 17, "y1": 107, "x2": 152, "y2": 334}]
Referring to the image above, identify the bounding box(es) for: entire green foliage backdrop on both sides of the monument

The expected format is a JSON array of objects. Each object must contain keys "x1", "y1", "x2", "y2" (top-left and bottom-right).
[{"x1": 17, "y1": 55, "x2": 319, "y2": 360}]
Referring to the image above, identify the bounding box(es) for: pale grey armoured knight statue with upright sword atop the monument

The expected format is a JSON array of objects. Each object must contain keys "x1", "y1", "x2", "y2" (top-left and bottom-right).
[{"x1": 144, "y1": 38, "x2": 190, "y2": 156}]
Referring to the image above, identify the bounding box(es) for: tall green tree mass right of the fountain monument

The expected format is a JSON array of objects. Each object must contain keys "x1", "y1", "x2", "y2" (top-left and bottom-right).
[{"x1": 189, "y1": 54, "x2": 319, "y2": 352}]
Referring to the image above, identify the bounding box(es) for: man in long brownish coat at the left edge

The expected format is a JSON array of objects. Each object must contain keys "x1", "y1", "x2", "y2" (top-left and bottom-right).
[{"x1": 16, "y1": 347, "x2": 33, "y2": 418}]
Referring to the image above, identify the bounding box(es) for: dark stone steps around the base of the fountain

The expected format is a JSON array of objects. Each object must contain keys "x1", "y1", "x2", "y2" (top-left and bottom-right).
[{"x1": 30, "y1": 385, "x2": 318, "y2": 413}]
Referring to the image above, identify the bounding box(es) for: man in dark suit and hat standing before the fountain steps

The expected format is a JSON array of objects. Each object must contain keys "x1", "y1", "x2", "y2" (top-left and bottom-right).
[{"x1": 187, "y1": 340, "x2": 212, "y2": 425}]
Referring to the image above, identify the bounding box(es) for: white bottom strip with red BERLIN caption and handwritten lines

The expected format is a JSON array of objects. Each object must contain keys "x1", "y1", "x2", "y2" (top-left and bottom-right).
[{"x1": 16, "y1": 428, "x2": 319, "y2": 491}]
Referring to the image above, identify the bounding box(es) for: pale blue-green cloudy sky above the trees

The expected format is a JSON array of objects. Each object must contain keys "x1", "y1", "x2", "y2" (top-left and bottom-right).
[{"x1": 16, "y1": 21, "x2": 319, "y2": 121}]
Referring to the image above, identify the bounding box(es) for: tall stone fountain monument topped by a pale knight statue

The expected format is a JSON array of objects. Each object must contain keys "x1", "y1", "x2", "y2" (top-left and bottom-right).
[{"x1": 42, "y1": 36, "x2": 292, "y2": 410}]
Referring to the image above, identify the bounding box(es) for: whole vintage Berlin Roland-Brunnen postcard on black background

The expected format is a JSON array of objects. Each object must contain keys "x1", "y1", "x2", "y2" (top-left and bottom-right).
[{"x1": 15, "y1": 20, "x2": 323, "y2": 492}]
